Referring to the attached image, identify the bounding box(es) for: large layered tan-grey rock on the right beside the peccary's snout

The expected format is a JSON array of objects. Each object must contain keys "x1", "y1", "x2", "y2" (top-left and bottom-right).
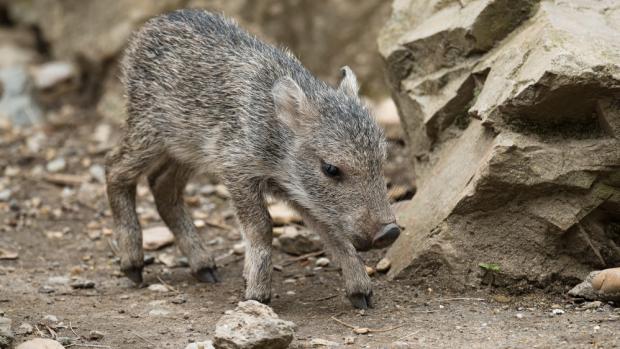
[{"x1": 379, "y1": 0, "x2": 620, "y2": 287}]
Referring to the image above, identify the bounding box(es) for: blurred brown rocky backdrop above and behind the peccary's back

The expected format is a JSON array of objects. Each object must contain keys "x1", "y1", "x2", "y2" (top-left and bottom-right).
[{"x1": 0, "y1": 0, "x2": 398, "y2": 124}]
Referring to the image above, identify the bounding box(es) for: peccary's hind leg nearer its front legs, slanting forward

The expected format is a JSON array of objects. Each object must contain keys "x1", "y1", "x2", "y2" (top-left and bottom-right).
[{"x1": 148, "y1": 160, "x2": 218, "y2": 283}]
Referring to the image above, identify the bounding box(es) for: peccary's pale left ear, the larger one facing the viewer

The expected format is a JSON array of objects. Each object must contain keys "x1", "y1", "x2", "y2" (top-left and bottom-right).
[{"x1": 271, "y1": 77, "x2": 310, "y2": 131}]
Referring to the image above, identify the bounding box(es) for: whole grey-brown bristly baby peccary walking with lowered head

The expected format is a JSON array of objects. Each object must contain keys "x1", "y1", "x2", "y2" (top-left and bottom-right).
[{"x1": 106, "y1": 10, "x2": 399, "y2": 308}]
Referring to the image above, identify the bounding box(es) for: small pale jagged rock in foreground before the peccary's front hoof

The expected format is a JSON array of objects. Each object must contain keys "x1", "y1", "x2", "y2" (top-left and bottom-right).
[{"x1": 213, "y1": 300, "x2": 295, "y2": 349}]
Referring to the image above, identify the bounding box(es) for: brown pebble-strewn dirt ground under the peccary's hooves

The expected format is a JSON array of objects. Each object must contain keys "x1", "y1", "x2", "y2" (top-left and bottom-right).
[{"x1": 0, "y1": 117, "x2": 620, "y2": 348}]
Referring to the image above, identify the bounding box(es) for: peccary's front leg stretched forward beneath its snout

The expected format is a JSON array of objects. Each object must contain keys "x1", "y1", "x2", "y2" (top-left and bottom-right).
[{"x1": 298, "y1": 208, "x2": 372, "y2": 309}]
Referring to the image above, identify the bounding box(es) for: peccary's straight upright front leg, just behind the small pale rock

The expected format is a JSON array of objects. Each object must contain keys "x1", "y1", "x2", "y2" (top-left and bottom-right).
[{"x1": 227, "y1": 181, "x2": 272, "y2": 303}]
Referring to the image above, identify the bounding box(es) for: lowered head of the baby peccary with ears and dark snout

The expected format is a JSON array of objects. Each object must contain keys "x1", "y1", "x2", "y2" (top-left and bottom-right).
[{"x1": 272, "y1": 67, "x2": 400, "y2": 251}]
